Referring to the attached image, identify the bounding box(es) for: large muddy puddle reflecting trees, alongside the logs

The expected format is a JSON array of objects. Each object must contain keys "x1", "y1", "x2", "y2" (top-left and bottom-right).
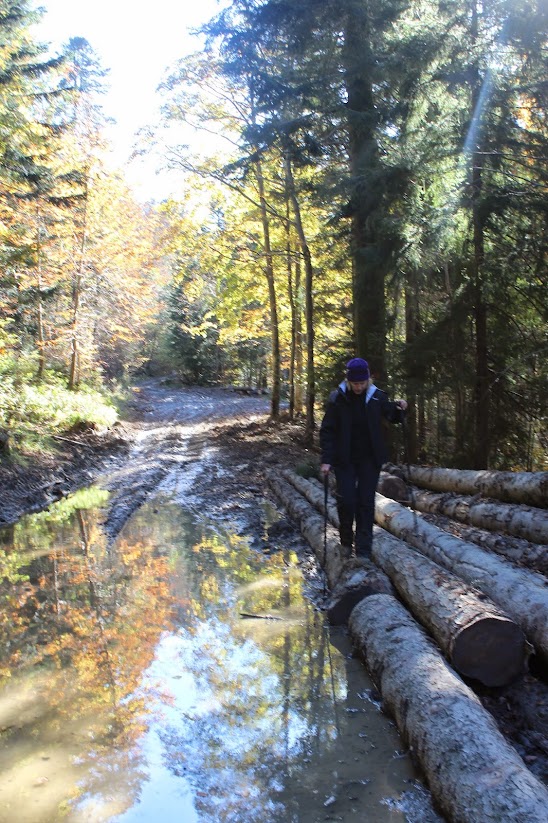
[{"x1": 0, "y1": 487, "x2": 435, "y2": 823}]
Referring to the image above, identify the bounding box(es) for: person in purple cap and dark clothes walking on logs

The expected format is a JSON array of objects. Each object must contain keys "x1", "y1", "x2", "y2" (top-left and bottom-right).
[{"x1": 320, "y1": 357, "x2": 407, "y2": 557}]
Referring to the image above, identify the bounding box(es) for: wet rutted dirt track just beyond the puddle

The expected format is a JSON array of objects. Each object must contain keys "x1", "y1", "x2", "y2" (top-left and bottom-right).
[{"x1": 98, "y1": 381, "x2": 278, "y2": 552}]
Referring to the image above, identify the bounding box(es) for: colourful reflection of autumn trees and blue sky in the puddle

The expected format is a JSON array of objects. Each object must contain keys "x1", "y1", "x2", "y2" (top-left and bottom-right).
[{"x1": 0, "y1": 495, "x2": 346, "y2": 823}]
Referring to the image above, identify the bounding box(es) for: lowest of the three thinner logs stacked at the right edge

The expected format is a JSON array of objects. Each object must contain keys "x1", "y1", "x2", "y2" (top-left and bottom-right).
[{"x1": 425, "y1": 514, "x2": 548, "y2": 575}]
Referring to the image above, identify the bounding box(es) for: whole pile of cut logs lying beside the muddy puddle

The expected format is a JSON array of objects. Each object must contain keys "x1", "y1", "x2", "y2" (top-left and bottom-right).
[{"x1": 272, "y1": 467, "x2": 548, "y2": 823}]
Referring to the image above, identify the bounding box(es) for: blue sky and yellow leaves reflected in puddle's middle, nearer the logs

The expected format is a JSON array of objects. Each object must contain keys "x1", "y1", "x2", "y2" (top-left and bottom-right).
[{"x1": 161, "y1": 536, "x2": 346, "y2": 822}]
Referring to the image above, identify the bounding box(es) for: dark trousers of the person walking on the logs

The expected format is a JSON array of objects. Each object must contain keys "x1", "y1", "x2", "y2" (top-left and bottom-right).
[{"x1": 335, "y1": 459, "x2": 380, "y2": 555}]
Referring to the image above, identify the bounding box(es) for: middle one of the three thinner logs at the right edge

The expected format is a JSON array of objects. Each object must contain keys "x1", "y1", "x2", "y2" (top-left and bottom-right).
[{"x1": 412, "y1": 489, "x2": 548, "y2": 543}]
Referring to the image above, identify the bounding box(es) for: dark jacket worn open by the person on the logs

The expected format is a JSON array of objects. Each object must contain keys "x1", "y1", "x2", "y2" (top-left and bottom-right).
[{"x1": 320, "y1": 382, "x2": 404, "y2": 470}]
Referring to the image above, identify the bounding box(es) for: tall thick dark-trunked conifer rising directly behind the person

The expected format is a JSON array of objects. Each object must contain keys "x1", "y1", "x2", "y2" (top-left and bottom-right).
[{"x1": 217, "y1": 0, "x2": 412, "y2": 378}]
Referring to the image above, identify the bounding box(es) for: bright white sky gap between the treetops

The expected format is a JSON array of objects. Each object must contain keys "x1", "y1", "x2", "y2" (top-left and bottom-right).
[{"x1": 34, "y1": 0, "x2": 224, "y2": 199}]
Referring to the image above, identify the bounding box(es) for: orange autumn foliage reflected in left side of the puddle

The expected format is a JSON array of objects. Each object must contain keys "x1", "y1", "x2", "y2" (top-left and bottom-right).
[{"x1": 0, "y1": 492, "x2": 180, "y2": 816}]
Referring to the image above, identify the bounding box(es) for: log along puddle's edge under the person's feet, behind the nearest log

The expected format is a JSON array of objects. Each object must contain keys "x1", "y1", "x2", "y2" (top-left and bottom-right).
[{"x1": 268, "y1": 473, "x2": 393, "y2": 625}]
